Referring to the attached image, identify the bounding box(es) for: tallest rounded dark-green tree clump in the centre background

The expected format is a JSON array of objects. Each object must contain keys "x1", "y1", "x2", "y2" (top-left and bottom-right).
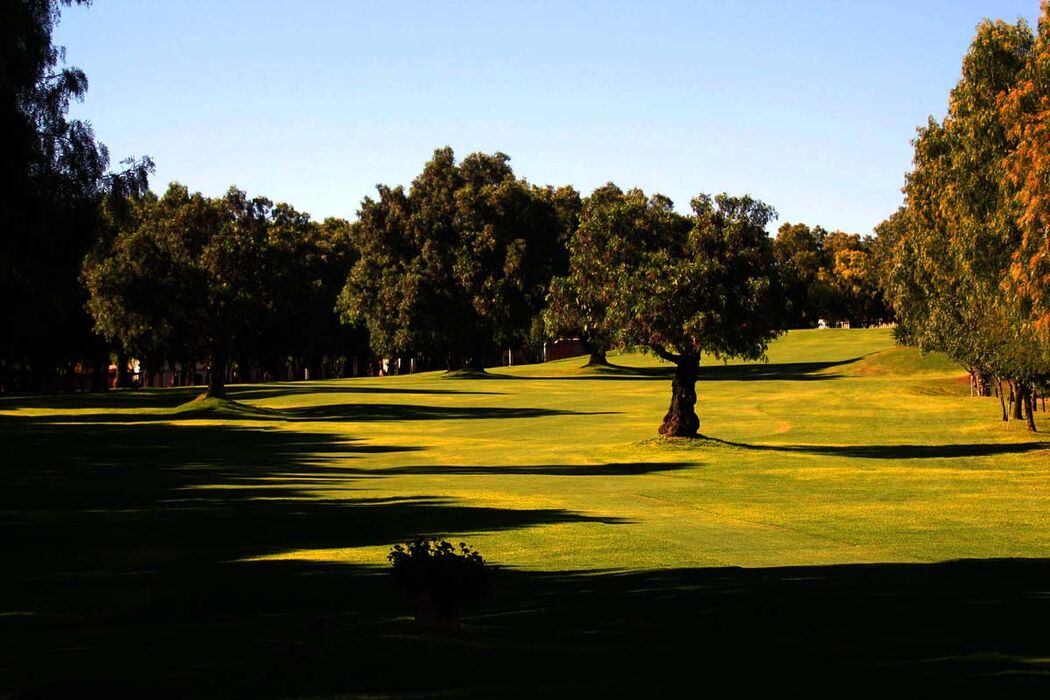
[{"x1": 339, "y1": 148, "x2": 579, "y2": 369}]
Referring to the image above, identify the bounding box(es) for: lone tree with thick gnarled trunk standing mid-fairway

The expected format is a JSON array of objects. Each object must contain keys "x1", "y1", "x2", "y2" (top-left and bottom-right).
[{"x1": 574, "y1": 185, "x2": 783, "y2": 438}]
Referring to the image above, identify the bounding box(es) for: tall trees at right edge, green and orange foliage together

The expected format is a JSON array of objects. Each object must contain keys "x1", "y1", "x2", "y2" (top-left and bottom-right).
[{"x1": 876, "y1": 4, "x2": 1050, "y2": 430}]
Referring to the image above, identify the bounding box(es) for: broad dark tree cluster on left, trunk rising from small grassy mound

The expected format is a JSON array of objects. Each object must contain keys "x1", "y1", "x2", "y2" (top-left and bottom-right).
[{"x1": 83, "y1": 184, "x2": 359, "y2": 397}]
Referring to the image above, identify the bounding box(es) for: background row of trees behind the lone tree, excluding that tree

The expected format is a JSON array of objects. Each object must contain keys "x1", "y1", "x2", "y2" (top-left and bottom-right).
[{"x1": 6, "y1": 140, "x2": 888, "y2": 396}]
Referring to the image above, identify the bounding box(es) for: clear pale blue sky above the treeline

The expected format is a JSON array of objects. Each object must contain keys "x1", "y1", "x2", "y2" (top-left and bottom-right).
[{"x1": 56, "y1": 0, "x2": 1038, "y2": 233}]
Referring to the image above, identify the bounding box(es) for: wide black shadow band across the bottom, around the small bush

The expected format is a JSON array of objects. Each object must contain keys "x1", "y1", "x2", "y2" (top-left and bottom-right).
[{"x1": 6, "y1": 559, "x2": 1050, "y2": 698}]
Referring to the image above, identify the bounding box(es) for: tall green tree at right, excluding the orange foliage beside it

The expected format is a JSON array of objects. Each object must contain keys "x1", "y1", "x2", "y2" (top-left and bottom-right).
[{"x1": 877, "y1": 15, "x2": 1050, "y2": 429}]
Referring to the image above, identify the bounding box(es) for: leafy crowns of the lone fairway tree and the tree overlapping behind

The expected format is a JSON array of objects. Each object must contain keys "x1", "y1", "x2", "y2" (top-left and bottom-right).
[{"x1": 546, "y1": 184, "x2": 782, "y2": 369}]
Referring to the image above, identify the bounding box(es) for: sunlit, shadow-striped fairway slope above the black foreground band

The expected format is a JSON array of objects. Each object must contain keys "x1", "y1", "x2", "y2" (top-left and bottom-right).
[{"x1": 0, "y1": 330, "x2": 1050, "y2": 570}]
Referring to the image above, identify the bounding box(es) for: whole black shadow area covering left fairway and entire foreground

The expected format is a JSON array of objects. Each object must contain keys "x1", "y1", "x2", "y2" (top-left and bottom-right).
[{"x1": 6, "y1": 413, "x2": 1050, "y2": 698}]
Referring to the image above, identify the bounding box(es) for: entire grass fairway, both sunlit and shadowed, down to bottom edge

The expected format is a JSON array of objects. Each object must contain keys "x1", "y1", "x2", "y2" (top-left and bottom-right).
[{"x1": 0, "y1": 330, "x2": 1050, "y2": 697}]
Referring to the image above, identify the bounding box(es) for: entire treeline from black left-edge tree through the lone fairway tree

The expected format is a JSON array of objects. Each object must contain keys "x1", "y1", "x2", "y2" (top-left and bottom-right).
[{"x1": 0, "y1": 0, "x2": 889, "y2": 434}]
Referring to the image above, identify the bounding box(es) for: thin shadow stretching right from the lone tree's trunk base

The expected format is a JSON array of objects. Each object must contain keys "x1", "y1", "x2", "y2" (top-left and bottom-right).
[{"x1": 700, "y1": 436, "x2": 1050, "y2": 460}]
